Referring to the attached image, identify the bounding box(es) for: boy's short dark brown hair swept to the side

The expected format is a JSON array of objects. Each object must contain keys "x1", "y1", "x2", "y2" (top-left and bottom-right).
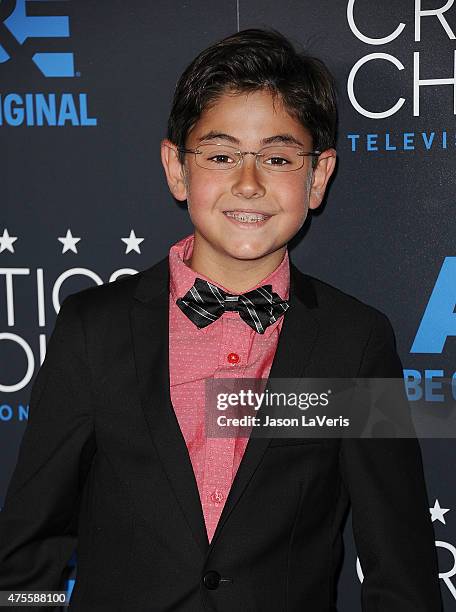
[{"x1": 167, "y1": 29, "x2": 337, "y2": 163}]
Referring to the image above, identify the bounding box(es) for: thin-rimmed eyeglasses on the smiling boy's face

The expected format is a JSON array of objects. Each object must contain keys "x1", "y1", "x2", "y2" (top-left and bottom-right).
[{"x1": 179, "y1": 143, "x2": 321, "y2": 172}]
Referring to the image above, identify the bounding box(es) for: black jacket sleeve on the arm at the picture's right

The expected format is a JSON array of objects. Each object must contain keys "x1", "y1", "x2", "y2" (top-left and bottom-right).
[{"x1": 340, "y1": 312, "x2": 442, "y2": 612}]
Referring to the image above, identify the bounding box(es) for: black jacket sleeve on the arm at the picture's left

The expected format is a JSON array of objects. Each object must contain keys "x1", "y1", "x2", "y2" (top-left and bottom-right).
[{"x1": 0, "y1": 294, "x2": 95, "y2": 591}]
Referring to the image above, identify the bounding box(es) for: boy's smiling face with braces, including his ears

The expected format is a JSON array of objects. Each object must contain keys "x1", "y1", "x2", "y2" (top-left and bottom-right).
[{"x1": 162, "y1": 90, "x2": 335, "y2": 260}]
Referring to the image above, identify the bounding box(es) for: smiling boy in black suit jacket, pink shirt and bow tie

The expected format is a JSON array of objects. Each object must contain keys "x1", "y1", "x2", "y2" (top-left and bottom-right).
[{"x1": 0, "y1": 30, "x2": 441, "y2": 612}]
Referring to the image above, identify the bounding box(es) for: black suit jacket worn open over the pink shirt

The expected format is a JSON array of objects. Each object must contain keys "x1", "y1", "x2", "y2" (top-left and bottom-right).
[{"x1": 0, "y1": 257, "x2": 441, "y2": 612}]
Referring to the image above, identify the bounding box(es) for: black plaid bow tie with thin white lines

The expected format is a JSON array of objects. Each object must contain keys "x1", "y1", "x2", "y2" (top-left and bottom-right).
[{"x1": 176, "y1": 278, "x2": 289, "y2": 334}]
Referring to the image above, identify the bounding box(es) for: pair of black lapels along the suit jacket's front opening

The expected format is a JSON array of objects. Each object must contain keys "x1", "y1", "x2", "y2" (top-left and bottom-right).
[{"x1": 131, "y1": 257, "x2": 318, "y2": 554}]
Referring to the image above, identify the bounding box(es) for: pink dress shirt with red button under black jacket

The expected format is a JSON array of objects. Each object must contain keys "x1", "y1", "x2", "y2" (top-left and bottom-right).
[{"x1": 169, "y1": 234, "x2": 290, "y2": 542}]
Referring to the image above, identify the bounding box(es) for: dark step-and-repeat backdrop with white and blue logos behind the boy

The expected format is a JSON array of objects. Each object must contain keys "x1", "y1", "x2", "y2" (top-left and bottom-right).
[{"x1": 0, "y1": 0, "x2": 456, "y2": 612}]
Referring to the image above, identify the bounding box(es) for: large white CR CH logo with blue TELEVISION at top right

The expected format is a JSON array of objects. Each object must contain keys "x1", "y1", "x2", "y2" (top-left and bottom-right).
[{"x1": 346, "y1": 0, "x2": 456, "y2": 159}]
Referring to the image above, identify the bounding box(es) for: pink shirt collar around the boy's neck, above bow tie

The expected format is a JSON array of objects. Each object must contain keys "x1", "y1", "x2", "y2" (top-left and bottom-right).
[{"x1": 169, "y1": 234, "x2": 290, "y2": 336}]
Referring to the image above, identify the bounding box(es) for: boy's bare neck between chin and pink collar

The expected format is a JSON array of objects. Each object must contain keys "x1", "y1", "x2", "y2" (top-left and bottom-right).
[{"x1": 185, "y1": 232, "x2": 287, "y2": 294}]
